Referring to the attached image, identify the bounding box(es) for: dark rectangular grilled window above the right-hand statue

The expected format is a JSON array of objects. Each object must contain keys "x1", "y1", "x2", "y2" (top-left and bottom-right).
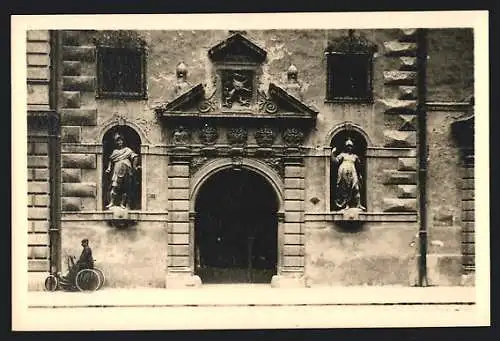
[{"x1": 327, "y1": 53, "x2": 372, "y2": 103}]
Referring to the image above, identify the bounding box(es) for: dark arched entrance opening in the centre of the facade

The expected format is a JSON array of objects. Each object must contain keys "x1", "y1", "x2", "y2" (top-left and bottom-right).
[{"x1": 195, "y1": 169, "x2": 278, "y2": 283}]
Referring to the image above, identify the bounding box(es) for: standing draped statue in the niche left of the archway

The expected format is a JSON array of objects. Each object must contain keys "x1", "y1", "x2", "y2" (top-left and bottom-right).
[{"x1": 106, "y1": 133, "x2": 140, "y2": 209}]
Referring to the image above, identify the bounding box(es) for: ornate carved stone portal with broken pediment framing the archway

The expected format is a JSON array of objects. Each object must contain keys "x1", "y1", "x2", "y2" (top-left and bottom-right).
[{"x1": 155, "y1": 33, "x2": 318, "y2": 287}]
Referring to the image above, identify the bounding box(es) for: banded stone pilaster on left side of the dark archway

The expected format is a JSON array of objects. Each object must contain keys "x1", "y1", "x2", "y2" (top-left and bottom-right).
[{"x1": 165, "y1": 156, "x2": 201, "y2": 288}]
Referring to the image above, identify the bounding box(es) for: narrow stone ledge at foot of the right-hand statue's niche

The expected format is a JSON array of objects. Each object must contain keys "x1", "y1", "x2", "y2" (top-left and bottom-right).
[{"x1": 304, "y1": 212, "x2": 417, "y2": 223}]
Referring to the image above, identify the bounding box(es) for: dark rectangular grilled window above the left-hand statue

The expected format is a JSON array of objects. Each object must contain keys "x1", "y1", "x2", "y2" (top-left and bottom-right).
[{"x1": 97, "y1": 46, "x2": 146, "y2": 99}]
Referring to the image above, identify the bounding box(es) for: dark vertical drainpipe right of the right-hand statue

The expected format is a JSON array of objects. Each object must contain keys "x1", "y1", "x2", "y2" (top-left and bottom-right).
[{"x1": 417, "y1": 29, "x2": 428, "y2": 287}]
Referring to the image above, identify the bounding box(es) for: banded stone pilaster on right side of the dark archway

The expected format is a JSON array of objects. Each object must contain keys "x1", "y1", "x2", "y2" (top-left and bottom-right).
[{"x1": 271, "y1": 157, "x2": 305, "y2": 287}]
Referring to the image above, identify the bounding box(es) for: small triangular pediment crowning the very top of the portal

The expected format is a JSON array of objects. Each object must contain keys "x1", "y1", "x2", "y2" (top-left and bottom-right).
[{"x1": 208, "y1": 33, "x2": 267, "y2": 63}]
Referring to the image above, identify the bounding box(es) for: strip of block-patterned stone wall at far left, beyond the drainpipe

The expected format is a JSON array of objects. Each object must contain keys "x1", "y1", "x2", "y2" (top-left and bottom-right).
[{"x1": 26, "y1": 30, "x2": 51, "y2": 289}]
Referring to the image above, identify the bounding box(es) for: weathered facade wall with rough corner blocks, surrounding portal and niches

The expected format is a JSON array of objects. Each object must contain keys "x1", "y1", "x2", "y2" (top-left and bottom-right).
[{"x1": 40, "y1": 29, "x2": 473, "y2": 286}]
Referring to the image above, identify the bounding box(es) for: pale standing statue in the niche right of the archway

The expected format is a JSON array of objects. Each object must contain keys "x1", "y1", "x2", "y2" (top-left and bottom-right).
[{"x1": 331, "y1": 139, "x2": 365, "y2": 210}]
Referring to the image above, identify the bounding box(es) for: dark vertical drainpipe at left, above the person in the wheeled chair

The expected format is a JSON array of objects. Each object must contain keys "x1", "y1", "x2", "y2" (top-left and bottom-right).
[{"x1": 48, "y1": 30, "x2": 61, "y2": 273}]
